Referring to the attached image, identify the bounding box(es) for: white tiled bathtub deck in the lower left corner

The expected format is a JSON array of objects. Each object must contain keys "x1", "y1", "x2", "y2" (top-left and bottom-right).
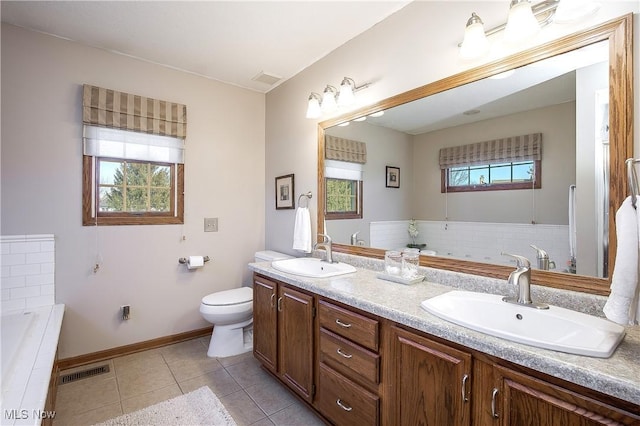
[{"x1": 0, "y1": 304, "x2": 65, "y2": 425}]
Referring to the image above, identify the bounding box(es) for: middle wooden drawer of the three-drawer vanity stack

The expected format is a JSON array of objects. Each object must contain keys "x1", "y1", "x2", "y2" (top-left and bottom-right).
[{"x1": 320, "y1": 328, "x2": 380, "y2": 385}]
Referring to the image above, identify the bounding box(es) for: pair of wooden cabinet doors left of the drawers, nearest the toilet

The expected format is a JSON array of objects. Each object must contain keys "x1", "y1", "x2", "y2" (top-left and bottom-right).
[{"x1": 253, "y1": 275, "x2": 314, "y2": 402}]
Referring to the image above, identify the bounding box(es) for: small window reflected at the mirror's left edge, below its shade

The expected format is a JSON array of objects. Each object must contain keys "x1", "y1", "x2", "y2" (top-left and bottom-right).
[{"x1": 325, "y1": 178, "x2": 362, "y2": 219}]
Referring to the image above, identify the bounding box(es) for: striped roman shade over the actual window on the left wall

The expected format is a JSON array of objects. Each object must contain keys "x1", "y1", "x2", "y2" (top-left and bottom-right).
[{"x1": 82, "y1": 84, "x2": 187, "y2": 139}]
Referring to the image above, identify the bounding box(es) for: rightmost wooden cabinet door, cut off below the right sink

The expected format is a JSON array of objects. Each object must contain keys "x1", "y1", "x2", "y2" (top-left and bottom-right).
[{"x1": 495, "y1": 366, "x2": 640, "y2": 426}]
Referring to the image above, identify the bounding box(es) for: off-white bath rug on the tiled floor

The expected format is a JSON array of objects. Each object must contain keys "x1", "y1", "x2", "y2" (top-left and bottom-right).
[{"x1": 95, "y1": 386, "x2": 236, "y2": 426}]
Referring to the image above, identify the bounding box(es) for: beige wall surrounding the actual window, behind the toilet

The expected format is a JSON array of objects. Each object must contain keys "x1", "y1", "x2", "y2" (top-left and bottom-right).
[{"x1": 2, "y1": 24, "x2": 266, "y2": 358}]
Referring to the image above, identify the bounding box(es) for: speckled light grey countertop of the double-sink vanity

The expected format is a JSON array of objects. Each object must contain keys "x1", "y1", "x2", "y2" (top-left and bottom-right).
[{"x1": 249, "y1": 260, "x2": 640, "y2": 404}]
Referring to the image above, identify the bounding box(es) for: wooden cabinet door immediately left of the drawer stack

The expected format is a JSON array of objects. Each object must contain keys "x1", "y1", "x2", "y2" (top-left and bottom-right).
[{"x1": 277, "y1": 286, "x2": 313, "y2": 402}]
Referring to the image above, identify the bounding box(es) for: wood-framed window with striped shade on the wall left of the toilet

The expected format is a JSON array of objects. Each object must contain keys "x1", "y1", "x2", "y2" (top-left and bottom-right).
[{"x1": 82, "y1": 85, "x2": 186, "y2": 225}]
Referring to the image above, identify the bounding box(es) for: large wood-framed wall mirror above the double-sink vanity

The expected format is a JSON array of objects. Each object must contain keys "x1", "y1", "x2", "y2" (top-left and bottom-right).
[{"x1": 317, "y1": 15, "x2": 633, "y2": 294}]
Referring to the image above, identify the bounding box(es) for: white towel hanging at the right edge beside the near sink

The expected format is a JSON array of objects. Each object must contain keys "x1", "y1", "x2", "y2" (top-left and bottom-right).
[{"x1": 603, "y1": 197, "x2": 640, "y2": 325}]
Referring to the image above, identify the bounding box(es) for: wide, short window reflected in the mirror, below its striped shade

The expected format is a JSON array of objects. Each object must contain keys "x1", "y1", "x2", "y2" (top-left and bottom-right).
[{"x1": 442, "y1": 161, "x2": 541, "y2": 192}]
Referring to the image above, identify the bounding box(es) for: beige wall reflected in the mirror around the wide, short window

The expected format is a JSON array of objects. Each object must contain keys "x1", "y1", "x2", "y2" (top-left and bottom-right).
[{"x1": 413, "y1": 102, "x2": 576, "y2": 225}]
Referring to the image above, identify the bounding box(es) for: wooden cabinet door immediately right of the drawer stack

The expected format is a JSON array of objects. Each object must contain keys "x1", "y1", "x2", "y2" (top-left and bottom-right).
[{"x1": 391, "y1": 327, "x2": 471, "y2": 426}]
